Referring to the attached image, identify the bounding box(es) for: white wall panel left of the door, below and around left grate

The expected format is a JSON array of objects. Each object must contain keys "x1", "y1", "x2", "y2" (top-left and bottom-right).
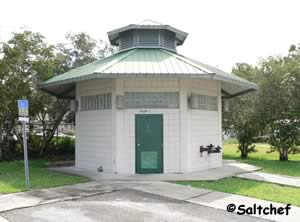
[{"x1": 75, "y1": 80, "x2": 113, "y2": 173}]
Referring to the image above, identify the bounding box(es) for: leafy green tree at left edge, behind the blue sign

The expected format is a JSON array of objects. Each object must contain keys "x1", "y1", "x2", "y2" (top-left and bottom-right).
[{"x1": 0, "y1": 31, "x2": 54, "y2": 158}]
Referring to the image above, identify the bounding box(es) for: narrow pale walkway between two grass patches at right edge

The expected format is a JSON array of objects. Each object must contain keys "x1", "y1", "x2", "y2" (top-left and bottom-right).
[{"x1": 236, "y1": 172, "x2": 300, "y2": 188}]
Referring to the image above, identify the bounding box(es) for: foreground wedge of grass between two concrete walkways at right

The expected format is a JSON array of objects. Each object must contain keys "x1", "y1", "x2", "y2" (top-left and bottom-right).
[{"x1": 177, "y1": 178, "x2": 300, "y2": 206}]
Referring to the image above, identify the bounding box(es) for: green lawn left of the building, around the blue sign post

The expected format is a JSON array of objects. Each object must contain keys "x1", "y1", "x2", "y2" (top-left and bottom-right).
[{"x1": 0, "y1": 160, "x2": 88, "y2": 193}]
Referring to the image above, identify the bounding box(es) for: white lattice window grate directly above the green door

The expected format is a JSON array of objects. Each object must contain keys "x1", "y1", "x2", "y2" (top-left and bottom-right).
[{"x1": 125, "y1": 92, "x2": 179, "y2": 109}]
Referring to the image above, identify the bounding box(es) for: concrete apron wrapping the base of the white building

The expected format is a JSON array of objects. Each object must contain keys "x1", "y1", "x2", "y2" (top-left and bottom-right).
[{"x1": 49, "y1": 160, "x2": 261, "y2": 181}]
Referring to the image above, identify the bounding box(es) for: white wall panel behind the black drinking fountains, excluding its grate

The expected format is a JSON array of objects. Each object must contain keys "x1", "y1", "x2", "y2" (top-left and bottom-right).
[{"x1": 188, "y1": 80, "x2": 222, "y2": 171}]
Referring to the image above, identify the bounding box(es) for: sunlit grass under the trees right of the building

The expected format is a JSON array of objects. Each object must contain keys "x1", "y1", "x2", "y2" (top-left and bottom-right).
[{"x1": 223, "y1": 144, "x2": 300, "y2": 177}]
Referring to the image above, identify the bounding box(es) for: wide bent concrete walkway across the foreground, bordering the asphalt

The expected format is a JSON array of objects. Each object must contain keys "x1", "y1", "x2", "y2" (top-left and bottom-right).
[{"x1": 0, "y1": 181, "x2": 300, "y2": 222}]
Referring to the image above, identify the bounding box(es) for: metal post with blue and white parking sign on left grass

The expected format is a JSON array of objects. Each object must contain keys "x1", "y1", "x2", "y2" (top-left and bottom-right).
[{"x1": 18, "y1": 100, "x2": 30, "y2": 190}]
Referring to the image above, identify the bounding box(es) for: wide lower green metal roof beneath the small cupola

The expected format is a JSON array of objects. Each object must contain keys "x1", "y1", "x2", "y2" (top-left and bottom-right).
[{"x1": 40, "y1": 49, "x2": 257, "y2": 96}]
